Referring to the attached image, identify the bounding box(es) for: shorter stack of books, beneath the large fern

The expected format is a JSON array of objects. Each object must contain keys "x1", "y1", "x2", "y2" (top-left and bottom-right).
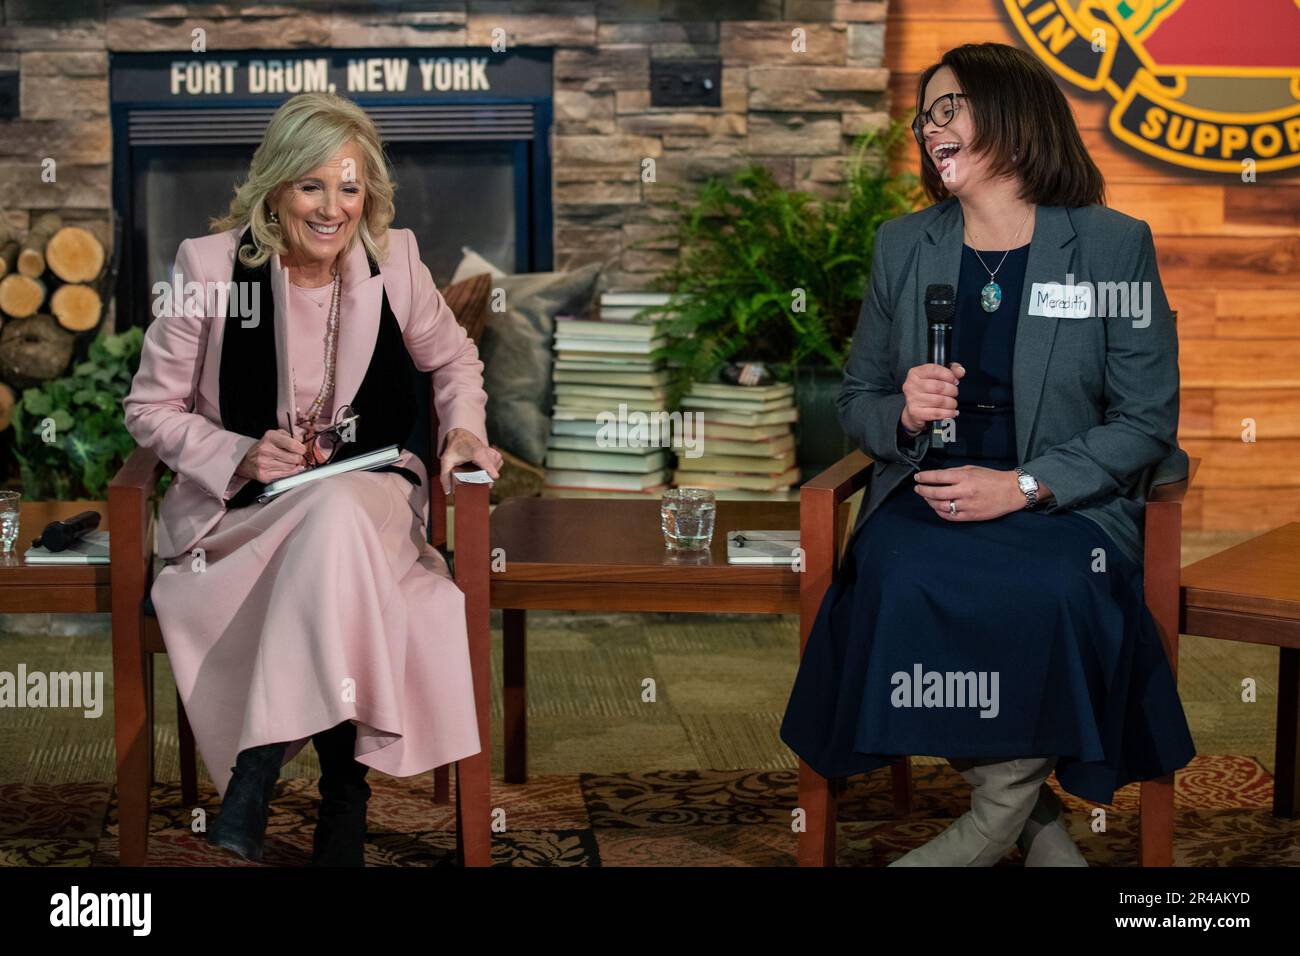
[{"x1": 673, "y1": 382, "x2": 800, "y2": 499}]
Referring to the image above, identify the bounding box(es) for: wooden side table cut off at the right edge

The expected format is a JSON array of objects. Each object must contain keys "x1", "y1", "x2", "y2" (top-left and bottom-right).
[{"x1": 1179, "y1": 522, "x2": 1300, "y2": 818}]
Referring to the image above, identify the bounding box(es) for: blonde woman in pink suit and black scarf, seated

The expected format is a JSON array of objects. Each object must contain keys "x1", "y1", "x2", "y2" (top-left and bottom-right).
[{"x1": 125, "y1": 94, "x2": 502, "y2": 865}]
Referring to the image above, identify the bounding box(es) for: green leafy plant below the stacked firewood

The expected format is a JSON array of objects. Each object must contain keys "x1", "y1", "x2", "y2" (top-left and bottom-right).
[{"x1": 13, "y1": 328, "x2": 158, "y2": 505}]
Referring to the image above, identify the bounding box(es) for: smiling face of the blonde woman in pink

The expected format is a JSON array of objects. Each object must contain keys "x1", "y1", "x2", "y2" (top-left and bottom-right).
[{"x1": 270, "y1": 142, "x2": 365, "y2": 274}]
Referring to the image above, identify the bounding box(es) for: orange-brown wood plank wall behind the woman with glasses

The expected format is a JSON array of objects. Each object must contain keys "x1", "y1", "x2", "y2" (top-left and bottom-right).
[{"x1": 885, "y1": 0, "x2": 1300, "y2": 531}]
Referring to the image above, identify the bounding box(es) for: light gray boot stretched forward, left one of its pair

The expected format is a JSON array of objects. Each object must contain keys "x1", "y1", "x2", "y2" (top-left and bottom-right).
[{"x1": 889, "y1": 757, "x2": 1056, "y2": 866}]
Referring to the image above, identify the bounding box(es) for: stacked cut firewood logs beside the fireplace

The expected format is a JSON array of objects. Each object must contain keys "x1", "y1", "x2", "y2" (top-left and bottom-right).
[{"x1": 0, "y1": 212, "x2": 105, "y2": 431}]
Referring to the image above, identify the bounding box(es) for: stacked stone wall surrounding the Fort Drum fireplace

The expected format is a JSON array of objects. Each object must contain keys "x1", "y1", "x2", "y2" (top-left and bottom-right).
[{"x1": 0, "y1": 0, "x2": 888, "y2": 303}]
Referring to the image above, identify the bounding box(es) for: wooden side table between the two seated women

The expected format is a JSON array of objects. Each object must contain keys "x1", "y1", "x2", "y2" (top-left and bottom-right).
[{"x1": 490, "y1": 498, "x2": 848, "y2": 783}]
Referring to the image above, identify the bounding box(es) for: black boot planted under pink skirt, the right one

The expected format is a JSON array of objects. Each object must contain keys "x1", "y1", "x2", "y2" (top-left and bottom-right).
[{"x1": 312, "y1": 721, "x2": 371, "y2": 866}]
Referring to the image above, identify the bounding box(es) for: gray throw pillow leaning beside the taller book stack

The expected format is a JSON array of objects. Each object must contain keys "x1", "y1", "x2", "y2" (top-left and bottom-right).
[{"x1": 480, "y1": 263, "x2": 601, "y2": 466}]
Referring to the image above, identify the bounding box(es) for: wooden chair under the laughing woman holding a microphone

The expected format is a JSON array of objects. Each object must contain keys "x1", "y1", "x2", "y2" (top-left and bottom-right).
[{"x1": 798, "y1": 451, "x2": 1200, "y2": 866}]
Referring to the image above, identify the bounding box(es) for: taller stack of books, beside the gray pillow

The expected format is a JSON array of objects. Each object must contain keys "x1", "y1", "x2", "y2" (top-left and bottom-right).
[{"x1": 542, "y1": 293, "x2": 672, "y2": 498}]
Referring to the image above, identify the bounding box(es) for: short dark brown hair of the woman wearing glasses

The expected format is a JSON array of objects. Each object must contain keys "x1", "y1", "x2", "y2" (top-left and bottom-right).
[{"x1": 917, "y1": 43, "x2": 1106, "y2": 207}]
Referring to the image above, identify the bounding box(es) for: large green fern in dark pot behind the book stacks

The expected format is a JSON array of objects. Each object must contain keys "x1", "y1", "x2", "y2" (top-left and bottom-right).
[{"x1": 639, "y1": 121, "x2": 920, "y2": 475}]
